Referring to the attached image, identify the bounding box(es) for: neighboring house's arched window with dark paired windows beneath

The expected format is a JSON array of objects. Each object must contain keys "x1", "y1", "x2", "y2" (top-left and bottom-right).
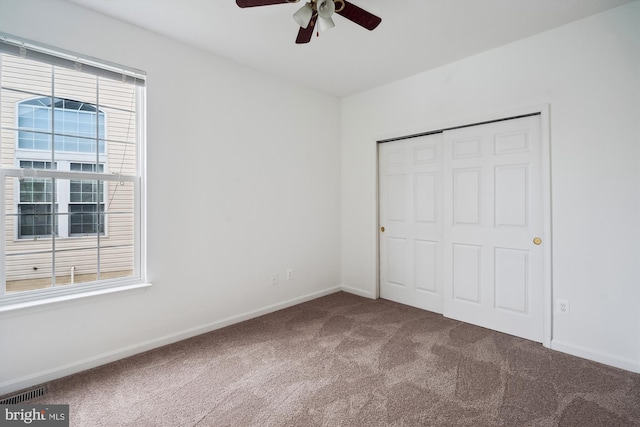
[{"x1": 15, "y1": 97, "x2": 106, "y2": 239}]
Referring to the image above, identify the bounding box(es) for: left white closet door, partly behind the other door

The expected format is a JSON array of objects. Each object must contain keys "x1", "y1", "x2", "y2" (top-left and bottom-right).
[{"x1": 378, "y1": 134, "x2": 443, "y2": 313}]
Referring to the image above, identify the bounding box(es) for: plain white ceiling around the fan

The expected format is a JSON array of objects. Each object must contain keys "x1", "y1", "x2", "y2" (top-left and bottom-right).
[{"x1": 67, "y1": 0, "x2": 634, "y2": 97}]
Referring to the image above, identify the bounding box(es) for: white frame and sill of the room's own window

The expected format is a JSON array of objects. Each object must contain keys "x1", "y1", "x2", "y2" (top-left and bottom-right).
[{"x1": 0, "y1": 32, "x2": 151, "y2": 312}]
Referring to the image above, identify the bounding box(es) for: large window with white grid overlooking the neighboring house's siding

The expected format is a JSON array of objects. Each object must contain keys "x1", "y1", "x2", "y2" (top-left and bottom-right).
[{"x1": 0, "y1": 34, "x2": 145, "y2": 309}]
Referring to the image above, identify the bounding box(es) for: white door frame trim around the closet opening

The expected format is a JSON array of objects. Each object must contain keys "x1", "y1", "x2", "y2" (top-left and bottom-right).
[{"x1": 372, "y1": 104, "x2": 553, "y2": 348}]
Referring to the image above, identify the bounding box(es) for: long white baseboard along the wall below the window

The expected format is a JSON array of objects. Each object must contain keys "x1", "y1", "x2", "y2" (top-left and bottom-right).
[{"x1": 0, "y1": 286, "x2": 342, "y2": 396}]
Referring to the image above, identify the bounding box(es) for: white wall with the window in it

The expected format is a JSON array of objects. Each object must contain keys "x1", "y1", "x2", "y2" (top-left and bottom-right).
[{"x1": 0, "y1": 0, "x2": 340, "y2": 394}]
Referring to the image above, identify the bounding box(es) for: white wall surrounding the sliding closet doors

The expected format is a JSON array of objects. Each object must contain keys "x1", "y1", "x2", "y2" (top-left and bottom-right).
[{"x1": 341, "y1": 2, "x2": 640, "y2": 372}]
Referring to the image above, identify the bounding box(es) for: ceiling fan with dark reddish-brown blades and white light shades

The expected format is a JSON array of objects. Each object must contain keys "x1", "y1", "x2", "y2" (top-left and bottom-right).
[{"x1": 236, "y1": 0, "x2": 382, "y2": 44}]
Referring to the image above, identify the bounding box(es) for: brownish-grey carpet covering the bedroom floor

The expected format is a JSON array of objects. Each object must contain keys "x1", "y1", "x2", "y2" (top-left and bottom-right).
[{"x1": 15, "y1": 293, "x2": 640, "y2": 427}]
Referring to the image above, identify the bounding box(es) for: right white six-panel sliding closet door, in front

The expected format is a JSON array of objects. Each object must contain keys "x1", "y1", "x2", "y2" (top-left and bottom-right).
[{"x1": 443, "y1": 116, "x2": 546, "y2": 342}]
